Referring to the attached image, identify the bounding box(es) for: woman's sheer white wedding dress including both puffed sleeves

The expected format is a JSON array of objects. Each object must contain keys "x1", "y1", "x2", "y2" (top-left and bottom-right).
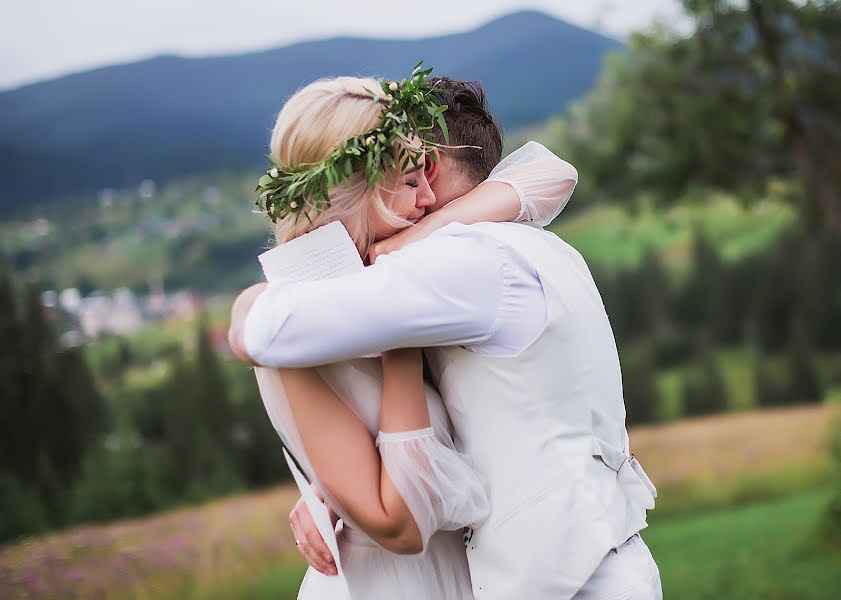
[{"x1": 255, "y1": 142, "x2": 577, "y2": 600}]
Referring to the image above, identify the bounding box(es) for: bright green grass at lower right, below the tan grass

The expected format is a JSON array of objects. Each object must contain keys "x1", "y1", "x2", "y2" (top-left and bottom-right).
[{"x1": 643, "y1": 490, "x2": 841, "y2": 600}]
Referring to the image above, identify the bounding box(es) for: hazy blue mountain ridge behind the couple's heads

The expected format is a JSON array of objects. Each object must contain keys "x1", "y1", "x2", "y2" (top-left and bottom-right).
[{"x1": 0, "y1": 12, "x2": 621, "y2": 212}]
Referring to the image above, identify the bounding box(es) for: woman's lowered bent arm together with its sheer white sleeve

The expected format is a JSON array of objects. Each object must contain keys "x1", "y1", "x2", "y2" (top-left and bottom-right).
[{"x1": 281, "y1": 349, "x2": 489, "y2": 556}]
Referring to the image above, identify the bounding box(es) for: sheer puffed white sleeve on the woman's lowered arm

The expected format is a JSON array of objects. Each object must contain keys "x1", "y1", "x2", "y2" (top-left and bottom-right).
[{"x1": 376, "y1": 427, "x2": 490, "y2": 550}]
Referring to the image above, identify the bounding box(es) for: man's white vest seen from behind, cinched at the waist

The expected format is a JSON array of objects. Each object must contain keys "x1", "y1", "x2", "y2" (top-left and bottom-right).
[{"x1": 425, "y1": 223, "x2": 655, "y2": 600}]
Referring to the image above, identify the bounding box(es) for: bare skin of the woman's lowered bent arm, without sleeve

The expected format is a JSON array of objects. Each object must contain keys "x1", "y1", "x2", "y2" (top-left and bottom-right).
[{"x1": 281, "y1": 358, "x2": 429, "y2": 554}]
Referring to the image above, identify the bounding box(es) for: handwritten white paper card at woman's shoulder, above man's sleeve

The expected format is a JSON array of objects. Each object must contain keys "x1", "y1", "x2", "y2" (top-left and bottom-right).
[{"x1": 258, "y1": 221, "x2": 365, "y2": 283}]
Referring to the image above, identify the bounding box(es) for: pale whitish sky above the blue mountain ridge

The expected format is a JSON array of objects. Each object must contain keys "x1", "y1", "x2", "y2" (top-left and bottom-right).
[{"x1": 0, "y1": 0, "x2": 686, "y2": 90}]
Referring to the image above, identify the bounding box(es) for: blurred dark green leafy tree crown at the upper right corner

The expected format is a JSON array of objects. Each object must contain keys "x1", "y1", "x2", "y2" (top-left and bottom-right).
[{"x1": 553, "y1": 0, "x2": 841, "y2": 231}]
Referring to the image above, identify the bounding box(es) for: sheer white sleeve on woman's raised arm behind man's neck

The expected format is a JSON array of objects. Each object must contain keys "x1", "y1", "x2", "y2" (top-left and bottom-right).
[{"x1": 487, "y1": 142, "x2": 578, "y2": 227}]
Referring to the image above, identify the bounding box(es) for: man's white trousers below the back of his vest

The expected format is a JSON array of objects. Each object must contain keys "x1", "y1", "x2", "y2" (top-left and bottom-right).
[{"x1": 573, "y1": 534, "x2": 663, "y2": 600}]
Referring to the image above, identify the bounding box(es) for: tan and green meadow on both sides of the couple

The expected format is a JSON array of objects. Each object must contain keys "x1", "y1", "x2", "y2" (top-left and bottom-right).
[{"x1": 0, "y1": 404, "x2": 841, "y2": 600}]
